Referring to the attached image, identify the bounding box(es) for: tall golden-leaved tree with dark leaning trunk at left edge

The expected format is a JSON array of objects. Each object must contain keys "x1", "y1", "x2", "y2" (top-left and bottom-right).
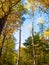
[{"x1": 0, "y1": 0, "x2": 23, "y2": 56}]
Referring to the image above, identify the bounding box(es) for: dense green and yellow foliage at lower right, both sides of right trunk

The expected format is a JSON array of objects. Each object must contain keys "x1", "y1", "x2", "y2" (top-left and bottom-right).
[{"x1": 21, "y1": 33, "x2": 49, "y2": 65}]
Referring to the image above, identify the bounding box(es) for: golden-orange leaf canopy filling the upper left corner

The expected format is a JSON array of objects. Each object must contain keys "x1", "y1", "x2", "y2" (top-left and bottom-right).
[{"x1": 0, "y1": 0, "x2": 23, "y2": 35}]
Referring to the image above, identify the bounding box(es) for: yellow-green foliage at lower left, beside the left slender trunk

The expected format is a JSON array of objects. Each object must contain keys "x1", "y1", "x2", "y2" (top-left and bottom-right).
[{"x1": 0, "y1": 37, "x2": 17, "y2": 65}]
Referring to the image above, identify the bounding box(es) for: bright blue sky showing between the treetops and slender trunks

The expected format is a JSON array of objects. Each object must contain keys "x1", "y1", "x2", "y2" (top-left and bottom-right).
[{"x1": 14, "y1": 11, "x2": 48, "y2": 49}]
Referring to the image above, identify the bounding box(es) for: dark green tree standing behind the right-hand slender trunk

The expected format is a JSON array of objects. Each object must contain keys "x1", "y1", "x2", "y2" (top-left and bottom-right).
[{"x1": 24, "y1": 34, "x2": 49, "y2": 65}]
